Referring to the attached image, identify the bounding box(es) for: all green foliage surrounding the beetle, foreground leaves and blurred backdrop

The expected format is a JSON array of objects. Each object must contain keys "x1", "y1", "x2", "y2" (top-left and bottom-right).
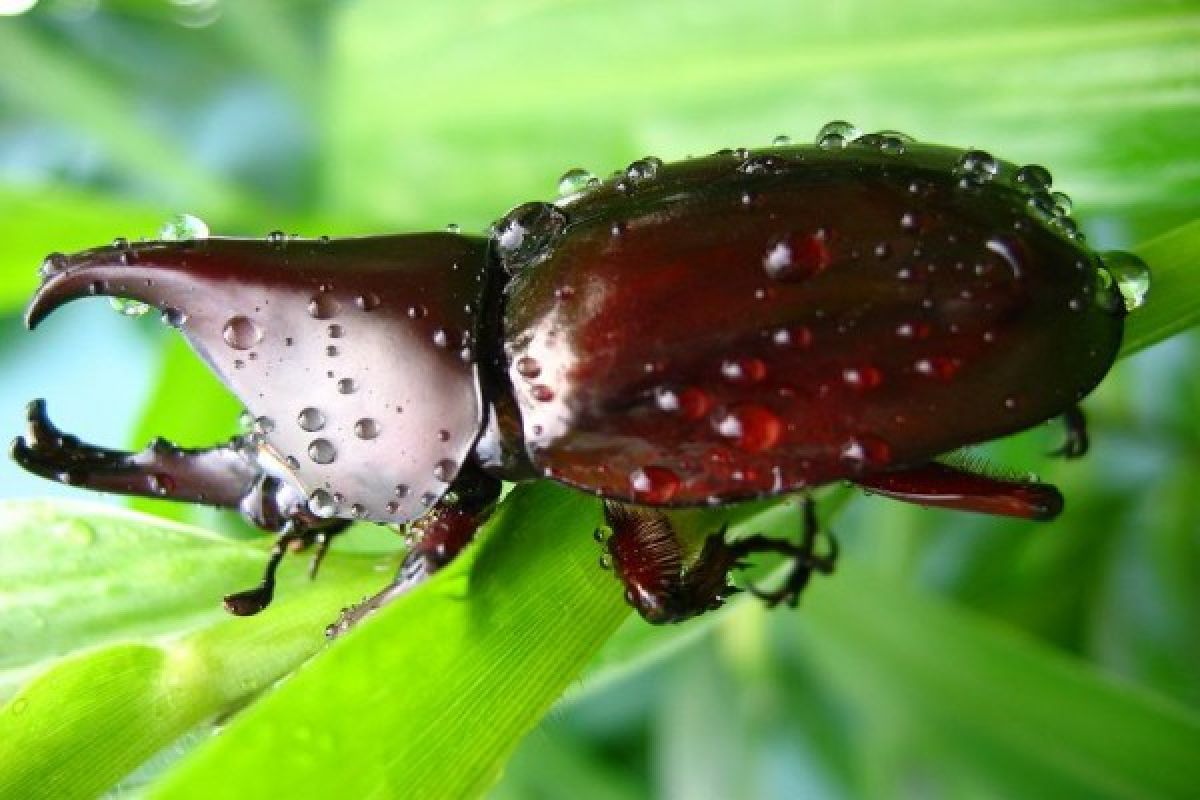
[{"x1": 0, "y1": 0, "x2": 1200, "y2": 800}]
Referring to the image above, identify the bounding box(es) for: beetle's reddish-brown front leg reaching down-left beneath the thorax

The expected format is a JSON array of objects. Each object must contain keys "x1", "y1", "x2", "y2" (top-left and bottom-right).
[{"x1": 325, "y1": 464, "x2": 502, "y2": 639}]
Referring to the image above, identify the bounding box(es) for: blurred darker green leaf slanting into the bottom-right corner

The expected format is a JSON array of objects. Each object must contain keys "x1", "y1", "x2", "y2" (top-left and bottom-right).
[{"x1": 797, "y1": 563, "x2": 1200, "y2": 798}]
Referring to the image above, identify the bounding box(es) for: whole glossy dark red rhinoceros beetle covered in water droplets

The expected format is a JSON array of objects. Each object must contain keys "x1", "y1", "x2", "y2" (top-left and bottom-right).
[{"x1": 13, "y1": 122, "x2": 1146, "y2": 632}]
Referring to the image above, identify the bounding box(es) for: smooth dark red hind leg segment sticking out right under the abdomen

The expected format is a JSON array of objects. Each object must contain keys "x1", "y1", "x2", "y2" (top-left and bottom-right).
[{"x1": 854, "y1": 462, "x2": 1062, "y2": 522}]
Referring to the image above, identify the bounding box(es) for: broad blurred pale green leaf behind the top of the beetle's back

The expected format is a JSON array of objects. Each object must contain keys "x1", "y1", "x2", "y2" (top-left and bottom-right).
[{"x1": 325, "y1": 0, "x2": 1200, "y2": 237}]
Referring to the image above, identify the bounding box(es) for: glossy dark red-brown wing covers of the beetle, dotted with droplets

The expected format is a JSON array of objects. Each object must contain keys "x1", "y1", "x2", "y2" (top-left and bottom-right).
[{"x1": 497, "y1": 136, "x2": 1124, "y2": 505}]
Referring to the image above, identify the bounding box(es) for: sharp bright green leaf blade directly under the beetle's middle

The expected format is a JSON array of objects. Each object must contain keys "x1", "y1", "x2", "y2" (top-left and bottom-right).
[{"x1": 156, "y1": 483, "x2": 629, "y2": 798}]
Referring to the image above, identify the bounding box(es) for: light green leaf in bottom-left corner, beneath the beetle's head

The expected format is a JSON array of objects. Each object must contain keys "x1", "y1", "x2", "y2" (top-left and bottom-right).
[{"x1": 0, "y1": 503, "x2": 379, "y2": 800}]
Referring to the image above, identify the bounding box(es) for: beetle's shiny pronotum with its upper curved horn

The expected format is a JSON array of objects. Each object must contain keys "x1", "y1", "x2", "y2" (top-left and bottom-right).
[{"x1": 26, "y1": 233, "x2": 488, "y2": 522}]
